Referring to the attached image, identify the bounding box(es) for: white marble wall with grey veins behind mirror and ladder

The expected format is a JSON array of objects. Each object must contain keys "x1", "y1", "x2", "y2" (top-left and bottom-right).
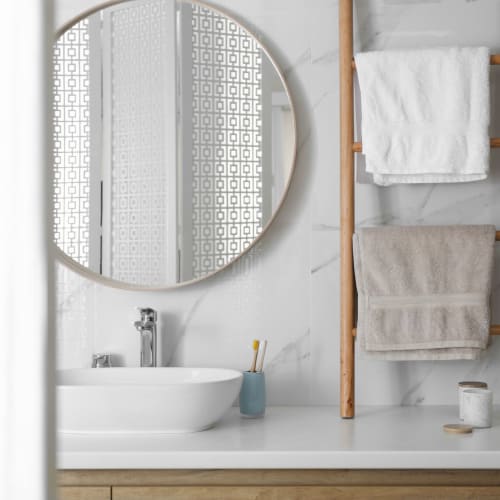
[{"x1": 54, "y1": 0, "x2": 500, "y2": 404}]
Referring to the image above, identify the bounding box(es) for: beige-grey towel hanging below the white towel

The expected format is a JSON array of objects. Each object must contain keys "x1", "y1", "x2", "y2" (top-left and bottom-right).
[{"x1": 353, "y1": 226, "x2": 495, "y2": 360}]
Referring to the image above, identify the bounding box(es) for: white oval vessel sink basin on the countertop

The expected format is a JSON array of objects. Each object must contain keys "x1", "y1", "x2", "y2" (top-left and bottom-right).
[{"x1": 57, "y1": 368, "x2": 243, "y2": 433}]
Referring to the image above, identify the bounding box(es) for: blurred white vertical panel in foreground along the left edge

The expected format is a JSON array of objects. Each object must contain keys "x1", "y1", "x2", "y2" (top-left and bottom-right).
[{"x1": 0, "y1": 0, "x2": 54, "y2": 500}]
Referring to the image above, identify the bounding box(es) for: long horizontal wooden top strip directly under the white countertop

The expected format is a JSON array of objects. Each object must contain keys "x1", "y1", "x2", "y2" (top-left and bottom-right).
[{"x1": 57, "y1": 469, "x2": 500, "y2": 488}]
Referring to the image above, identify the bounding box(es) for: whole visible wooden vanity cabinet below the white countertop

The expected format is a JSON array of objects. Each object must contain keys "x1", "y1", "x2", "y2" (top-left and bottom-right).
[{"x1": 58, "y1": 469, "x2": 500, "y2": 500}]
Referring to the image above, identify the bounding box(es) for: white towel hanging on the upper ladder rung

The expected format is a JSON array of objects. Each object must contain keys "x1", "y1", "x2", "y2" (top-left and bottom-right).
[{"x1": 356, "y1": 47, "x2": 490, "y2": 186}]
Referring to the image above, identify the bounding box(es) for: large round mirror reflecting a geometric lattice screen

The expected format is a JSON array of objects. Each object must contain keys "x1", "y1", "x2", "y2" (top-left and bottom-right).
[{"x1": 53, "y1": 0, "x2": 296, "y2": 288}]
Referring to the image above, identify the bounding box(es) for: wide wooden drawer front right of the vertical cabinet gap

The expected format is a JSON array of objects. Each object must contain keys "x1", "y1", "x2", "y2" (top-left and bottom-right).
[{"x1": 113, "y1": 486, "x2": 500, "y2": 500}]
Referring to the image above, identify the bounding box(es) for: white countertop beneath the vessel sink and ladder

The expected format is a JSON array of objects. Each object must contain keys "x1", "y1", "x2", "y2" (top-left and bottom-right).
[{"x1": 57, "y1": 406, "x2": 500, "y2": 469}]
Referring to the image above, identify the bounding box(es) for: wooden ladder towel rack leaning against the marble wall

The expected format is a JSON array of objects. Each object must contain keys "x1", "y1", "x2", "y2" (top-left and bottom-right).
[{"x1": 339, "y1": 0, "x2": 500, "y2": 418}]
